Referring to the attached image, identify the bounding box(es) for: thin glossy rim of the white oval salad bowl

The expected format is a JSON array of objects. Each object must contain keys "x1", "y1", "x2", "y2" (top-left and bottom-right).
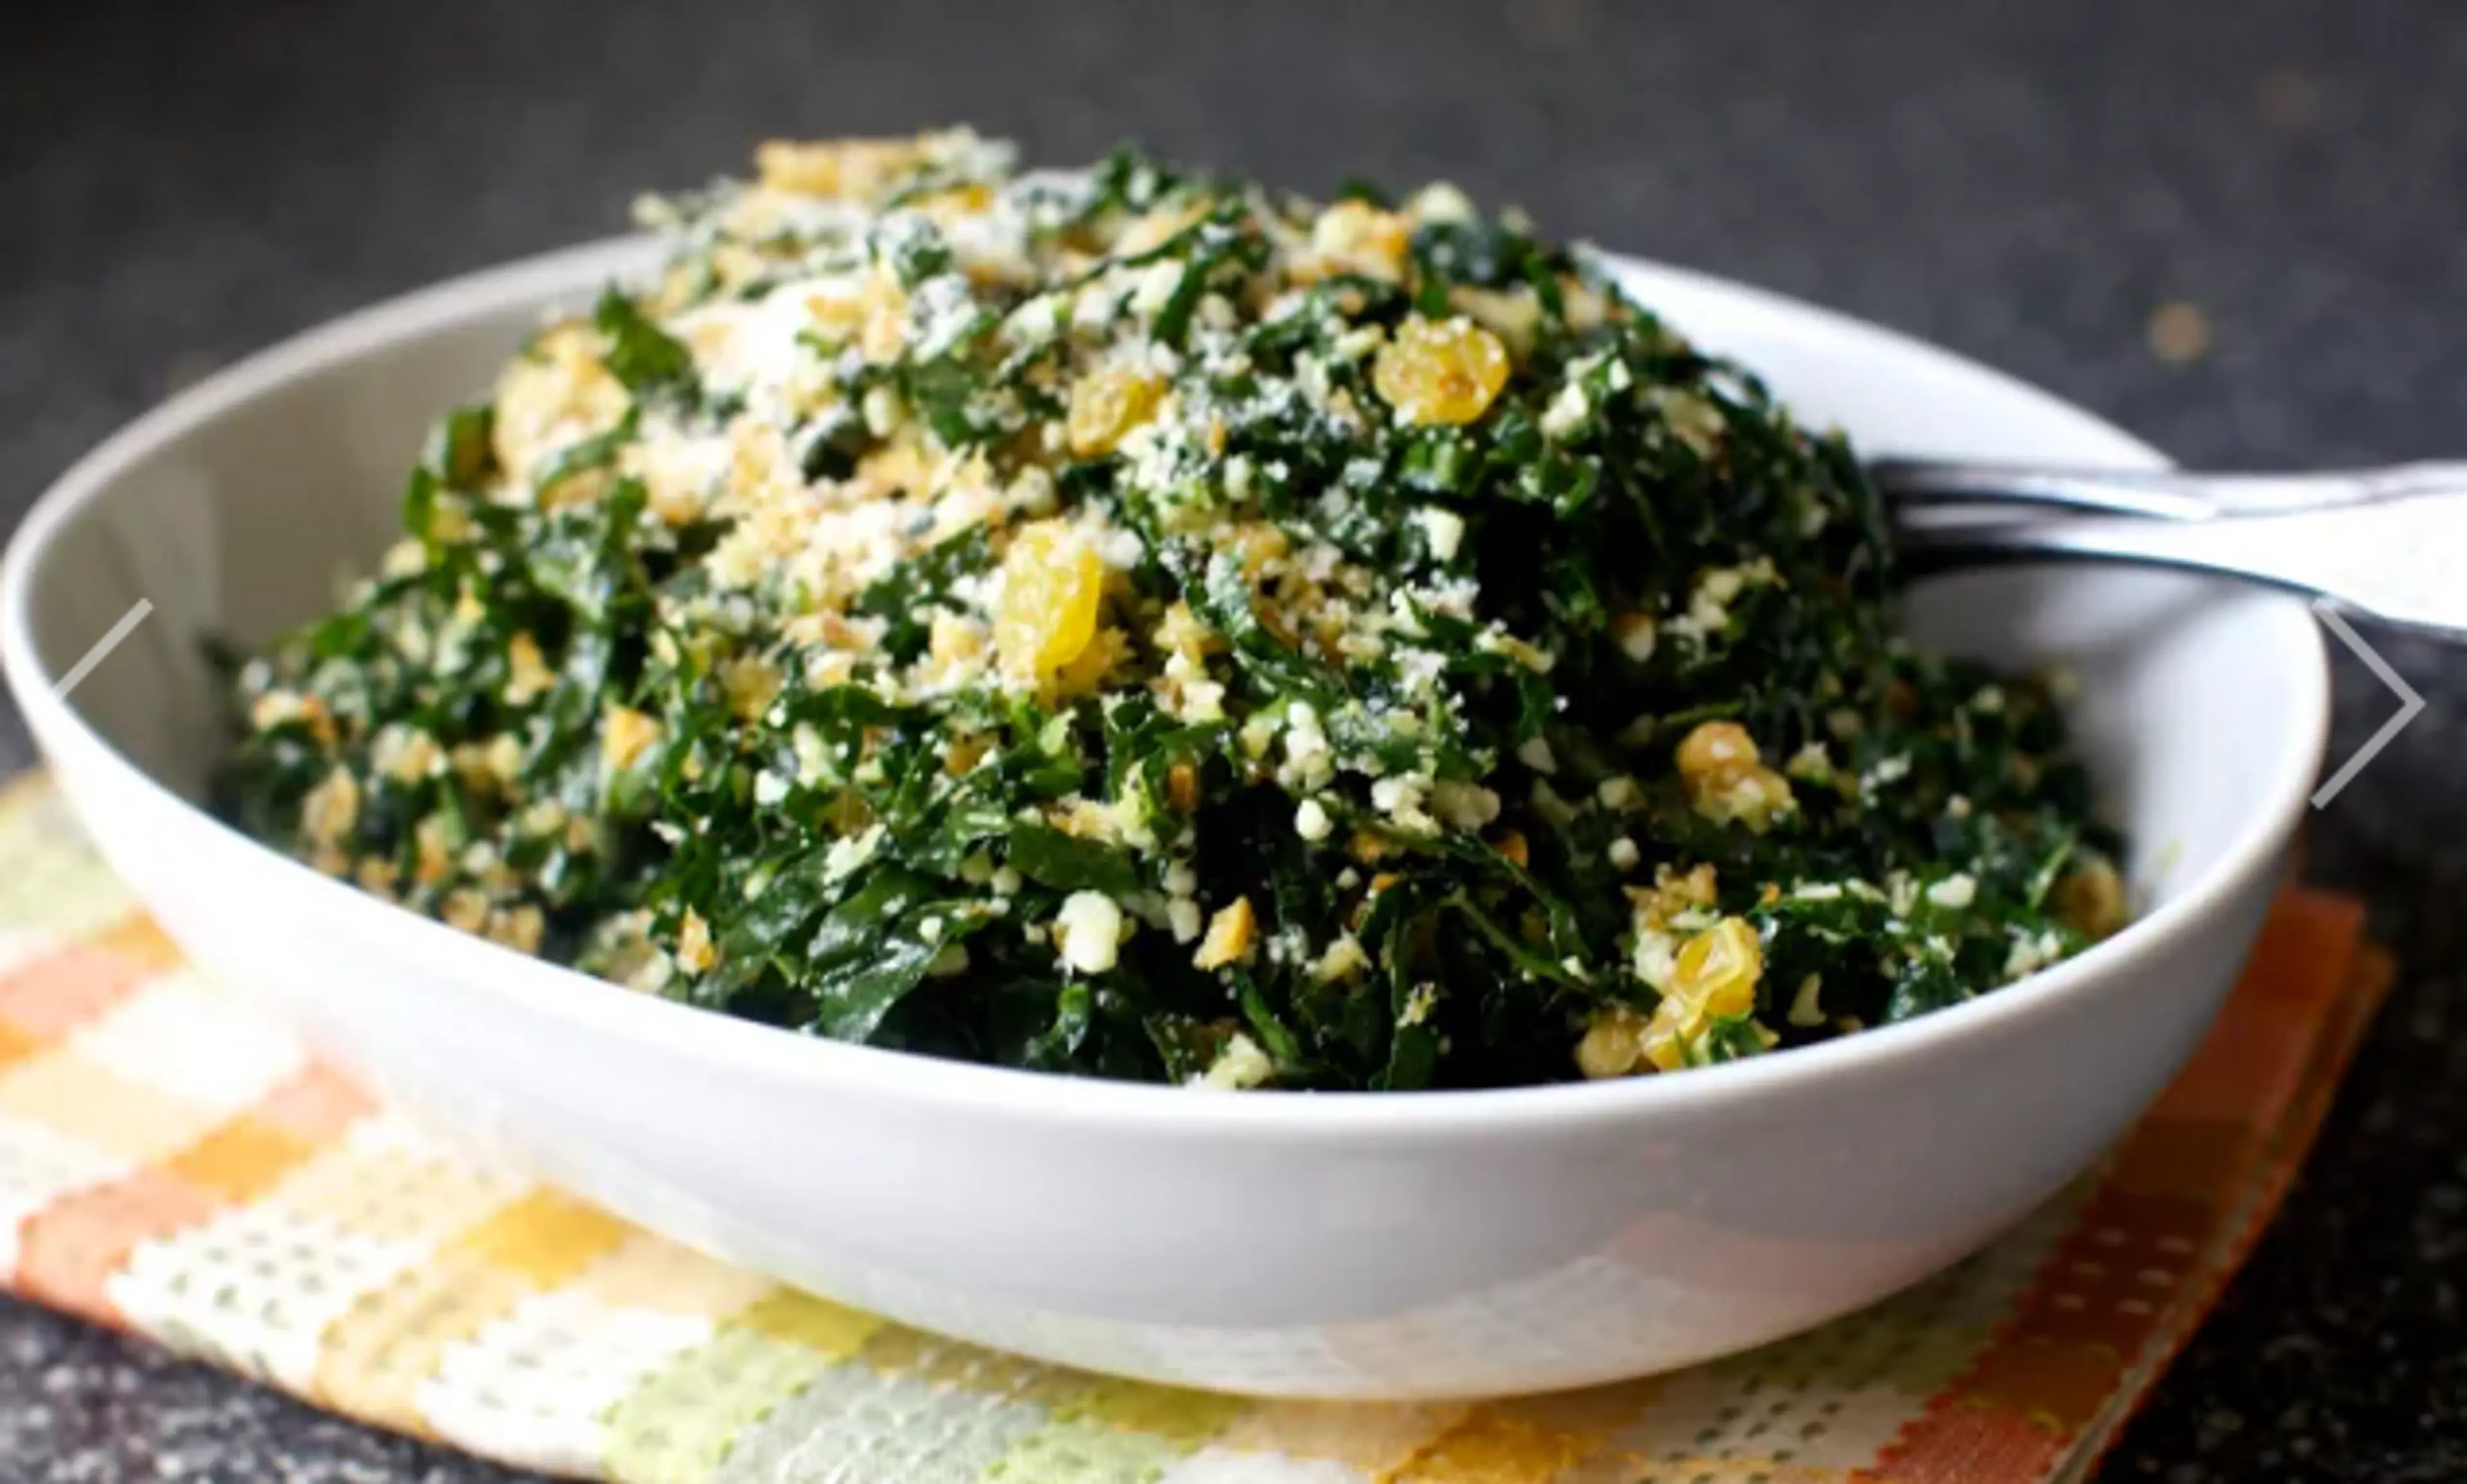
[{"x1": 0, "y1": 234, "x2": 2329, "y2": 1139}]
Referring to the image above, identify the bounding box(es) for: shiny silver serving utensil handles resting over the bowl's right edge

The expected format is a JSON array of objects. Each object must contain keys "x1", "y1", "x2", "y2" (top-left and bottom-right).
[{"x1": 1870, "y1": 461, "x2": 2467, "y2": 641}]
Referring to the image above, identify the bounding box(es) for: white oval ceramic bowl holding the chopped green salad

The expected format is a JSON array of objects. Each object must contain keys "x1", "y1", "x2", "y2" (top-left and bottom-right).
[{"x1": 0, "y1": 242, "x2": 2326, "y2": 1398}]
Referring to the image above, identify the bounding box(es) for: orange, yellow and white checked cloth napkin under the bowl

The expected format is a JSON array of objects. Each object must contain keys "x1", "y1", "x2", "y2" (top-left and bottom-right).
[{"x1": 0, "y1": 779, "x2": 2388, "y2": 1484}]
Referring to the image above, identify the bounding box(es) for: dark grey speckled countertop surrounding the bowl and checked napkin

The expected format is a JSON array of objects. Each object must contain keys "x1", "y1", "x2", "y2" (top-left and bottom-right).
[{"x1": 0, "y1": 0, "x2": 2467, "y2": 1484}]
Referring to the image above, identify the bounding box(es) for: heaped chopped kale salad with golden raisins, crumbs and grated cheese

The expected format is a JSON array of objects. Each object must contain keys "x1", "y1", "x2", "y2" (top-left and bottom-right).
[{"x1": 220, "y1": 130, "x2": 2124, "y2": 1090}]
